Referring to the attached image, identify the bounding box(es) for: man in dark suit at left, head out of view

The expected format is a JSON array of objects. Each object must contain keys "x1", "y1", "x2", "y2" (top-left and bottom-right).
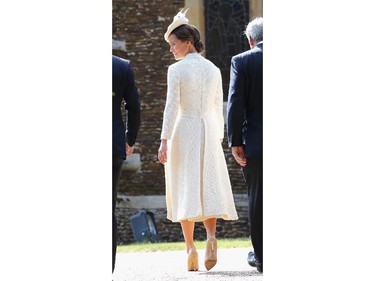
[{"x1": 112, "y1": 56, "x2": 141, "y2": 272}]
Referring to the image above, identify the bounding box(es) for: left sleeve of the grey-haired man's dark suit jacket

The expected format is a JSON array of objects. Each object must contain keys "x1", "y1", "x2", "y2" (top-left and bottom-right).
[{"x1": 227, "y1": 57, "x2": 245, "y2": 147}]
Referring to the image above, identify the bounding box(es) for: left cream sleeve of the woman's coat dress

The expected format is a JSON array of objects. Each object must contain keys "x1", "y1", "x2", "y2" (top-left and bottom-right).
[{"x1": 161, "y1": 65, "x2": 180, "y2": 139}]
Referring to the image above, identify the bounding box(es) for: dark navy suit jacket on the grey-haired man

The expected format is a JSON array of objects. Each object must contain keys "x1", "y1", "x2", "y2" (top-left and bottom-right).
[{"x1": 227, "y1": 43, "x2": 263, "y2": 158}]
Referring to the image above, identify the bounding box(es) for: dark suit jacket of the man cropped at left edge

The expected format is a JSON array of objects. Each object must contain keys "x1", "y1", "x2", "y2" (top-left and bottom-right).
[{"x1": 112, "y1": 55, "x2": 141, "y2": 158}]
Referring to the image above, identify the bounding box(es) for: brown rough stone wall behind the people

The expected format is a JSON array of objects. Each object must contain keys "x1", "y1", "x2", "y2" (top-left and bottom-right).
[{"x1": 112, "y1": 0, "x2": 248, "y2": 244}]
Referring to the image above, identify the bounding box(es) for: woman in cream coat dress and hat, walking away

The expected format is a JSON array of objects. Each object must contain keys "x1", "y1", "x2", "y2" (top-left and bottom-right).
[{"x1": 158, "y1": 8, "x2": 238, "y2": 271}]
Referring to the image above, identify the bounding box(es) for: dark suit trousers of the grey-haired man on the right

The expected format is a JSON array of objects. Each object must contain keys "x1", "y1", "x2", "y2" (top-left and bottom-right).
[{"x1": 242, "y1": 155, "x2": 263, "y2": 264}]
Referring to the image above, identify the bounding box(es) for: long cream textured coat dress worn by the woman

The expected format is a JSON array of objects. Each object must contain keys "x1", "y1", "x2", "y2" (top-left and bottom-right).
[{"x1": 161, "y1": 53, "x2": 238, "y2": 222}]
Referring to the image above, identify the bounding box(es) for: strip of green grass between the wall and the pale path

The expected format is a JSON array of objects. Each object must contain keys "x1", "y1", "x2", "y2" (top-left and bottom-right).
[{"x1": 117, "y1": 237, "x2": 251, "y2": 253}]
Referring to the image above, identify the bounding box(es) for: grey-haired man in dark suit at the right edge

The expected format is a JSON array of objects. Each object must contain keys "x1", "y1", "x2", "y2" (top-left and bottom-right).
[{"x1": 227, "y1": 18, "x2": 263, "y2": 272}]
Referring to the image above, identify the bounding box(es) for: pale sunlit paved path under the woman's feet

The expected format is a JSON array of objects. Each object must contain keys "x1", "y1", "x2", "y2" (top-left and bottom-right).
[{"x1": 113, "y1": 248, "x2": 263, "y2": 281}]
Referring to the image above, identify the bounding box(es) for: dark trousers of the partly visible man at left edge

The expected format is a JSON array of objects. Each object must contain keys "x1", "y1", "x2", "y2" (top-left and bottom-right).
[{"x1": 112, "y1": 156, "x2": 123, "y2": 273}]
